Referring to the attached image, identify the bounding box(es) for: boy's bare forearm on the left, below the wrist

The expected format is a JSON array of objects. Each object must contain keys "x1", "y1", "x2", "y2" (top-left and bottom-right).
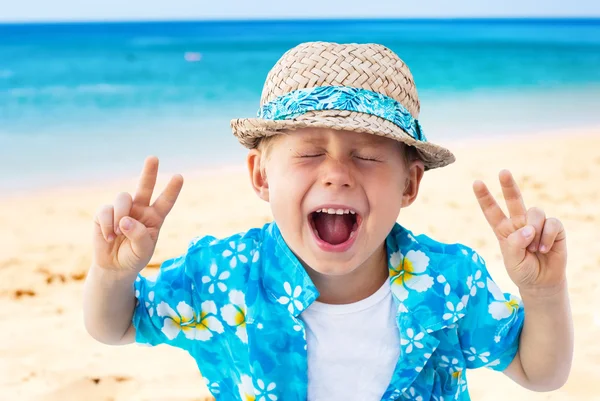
[{"x1": 83, "y1": 266, "x2": 137, "y2": 345}]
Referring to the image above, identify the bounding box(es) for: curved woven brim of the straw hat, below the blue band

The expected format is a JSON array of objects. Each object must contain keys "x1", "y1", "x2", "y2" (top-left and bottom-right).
[{"x1": 231, "y1": 110, "x2": 456, "y2": 170}]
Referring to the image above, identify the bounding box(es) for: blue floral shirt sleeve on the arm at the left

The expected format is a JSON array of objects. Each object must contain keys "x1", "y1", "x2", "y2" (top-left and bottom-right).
[{"x1": 133, "y1": 255, "x2": 196, "y2": 348}]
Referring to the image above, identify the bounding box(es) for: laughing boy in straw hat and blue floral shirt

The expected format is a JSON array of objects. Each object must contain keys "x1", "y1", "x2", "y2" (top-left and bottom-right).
[{"x1": 84, "y1": 42, "x2": 573, "y2": 401}]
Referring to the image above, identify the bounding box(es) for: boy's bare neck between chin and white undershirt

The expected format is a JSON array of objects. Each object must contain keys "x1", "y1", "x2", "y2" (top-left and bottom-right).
[{"x1": 306, "y1": 246, "x2": 389, "y2": 305}]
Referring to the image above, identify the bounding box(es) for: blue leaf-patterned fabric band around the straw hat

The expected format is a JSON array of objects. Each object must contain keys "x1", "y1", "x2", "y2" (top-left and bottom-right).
[{"x1": 257, "y1": 86, "x2": 427, "y2": 142}]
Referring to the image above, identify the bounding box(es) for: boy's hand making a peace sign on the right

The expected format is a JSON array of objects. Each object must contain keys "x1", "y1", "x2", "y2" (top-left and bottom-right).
[{"x1": 473, "y1": 170, "x2": 567, "y2": 290}]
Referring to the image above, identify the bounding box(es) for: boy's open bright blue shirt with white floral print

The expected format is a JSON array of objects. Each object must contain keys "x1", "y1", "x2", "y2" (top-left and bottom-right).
[{"x1": 133, "y1": 223, "x2": 524, "y2": 401}]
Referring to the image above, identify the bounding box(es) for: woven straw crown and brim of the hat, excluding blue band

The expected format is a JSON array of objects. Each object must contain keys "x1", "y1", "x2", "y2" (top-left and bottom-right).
[{"x1": 231, "y1": 42, "x2": 455, "y2": 170}]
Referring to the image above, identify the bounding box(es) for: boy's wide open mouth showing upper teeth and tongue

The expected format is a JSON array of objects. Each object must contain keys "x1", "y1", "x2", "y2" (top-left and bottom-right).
[{"x1": 308, "y1": 208, "x2": 362, "y2": 247}]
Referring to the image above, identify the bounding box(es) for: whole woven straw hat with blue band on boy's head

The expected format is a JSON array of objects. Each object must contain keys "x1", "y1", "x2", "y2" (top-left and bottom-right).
[{"x1": 231, "y1": 42, "x2": 455, "y2": 169}]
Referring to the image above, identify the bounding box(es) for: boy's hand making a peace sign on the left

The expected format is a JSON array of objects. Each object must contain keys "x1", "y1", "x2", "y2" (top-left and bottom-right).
[{"x1": 93, "y1": 157, "x2": 183, "y2": 273}]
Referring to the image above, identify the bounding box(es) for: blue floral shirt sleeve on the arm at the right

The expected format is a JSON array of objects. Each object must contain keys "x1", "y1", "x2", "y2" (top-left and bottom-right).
[{"x1": 458, "y1": 253, "x2": 525, "y2": 371}]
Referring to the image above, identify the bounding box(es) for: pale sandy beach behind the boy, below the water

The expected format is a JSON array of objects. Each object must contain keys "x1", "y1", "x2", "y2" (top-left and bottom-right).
[{"x1": 0, "y1": 128, "x2": 600, "y2": 401}]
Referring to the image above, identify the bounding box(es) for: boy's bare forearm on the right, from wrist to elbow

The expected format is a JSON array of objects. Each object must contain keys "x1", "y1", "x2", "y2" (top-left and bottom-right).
[{"x1": 515, "y1": 284, "x2": 573, "y2": 391}]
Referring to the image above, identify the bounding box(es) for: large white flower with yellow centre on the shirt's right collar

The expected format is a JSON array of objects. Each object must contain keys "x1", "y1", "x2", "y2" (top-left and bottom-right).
[{"x1": 390, "y1": 250, "x2": 433, "y2": 301}]
